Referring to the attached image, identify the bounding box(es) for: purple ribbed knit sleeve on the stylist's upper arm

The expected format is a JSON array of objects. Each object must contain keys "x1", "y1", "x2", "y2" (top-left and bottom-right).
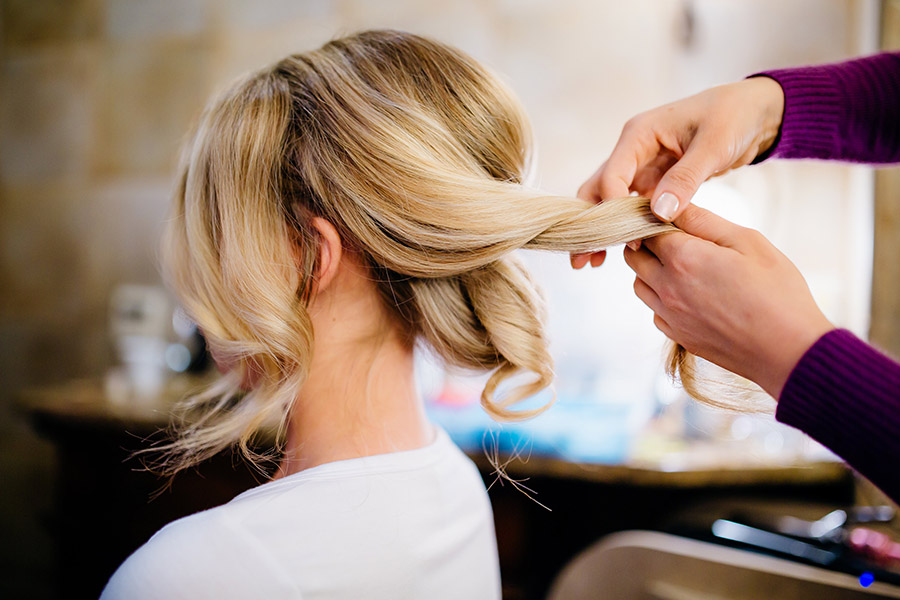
[{"x1": 751, "y1": 52, "x2": 900, "y2": 164}]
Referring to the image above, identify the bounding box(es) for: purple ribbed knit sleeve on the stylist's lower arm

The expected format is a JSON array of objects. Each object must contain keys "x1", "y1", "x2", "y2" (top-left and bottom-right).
[{"x1": 775, "y1": 329, "x2": 900, "y2": 502}]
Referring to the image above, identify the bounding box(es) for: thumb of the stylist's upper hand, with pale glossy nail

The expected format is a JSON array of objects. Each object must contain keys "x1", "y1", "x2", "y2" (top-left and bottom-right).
[{"x1": 650, "y1": 135, "x2": 719, "y2": 221}]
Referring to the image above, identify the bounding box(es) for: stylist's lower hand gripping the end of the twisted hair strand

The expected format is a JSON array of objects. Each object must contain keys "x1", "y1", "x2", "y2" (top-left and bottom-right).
[{"x1": 625, "y1": 206, "x2": 834, "y2": 399}]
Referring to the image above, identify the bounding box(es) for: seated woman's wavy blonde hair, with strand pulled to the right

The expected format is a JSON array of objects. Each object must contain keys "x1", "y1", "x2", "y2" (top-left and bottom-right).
[{"x1": 163, "y1": 31, "x2": 704, "y2": 473}]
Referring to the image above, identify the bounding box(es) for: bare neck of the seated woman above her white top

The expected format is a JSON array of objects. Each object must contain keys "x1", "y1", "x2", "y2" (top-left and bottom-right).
[{"x1": 275, "y1": 333, "x2": 433, "y2": 479}]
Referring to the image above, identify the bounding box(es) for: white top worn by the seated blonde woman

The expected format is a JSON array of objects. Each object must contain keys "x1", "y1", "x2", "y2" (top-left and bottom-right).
[{"x1": 101, "y1": 428, "x2": 500, "y2": 600}]
